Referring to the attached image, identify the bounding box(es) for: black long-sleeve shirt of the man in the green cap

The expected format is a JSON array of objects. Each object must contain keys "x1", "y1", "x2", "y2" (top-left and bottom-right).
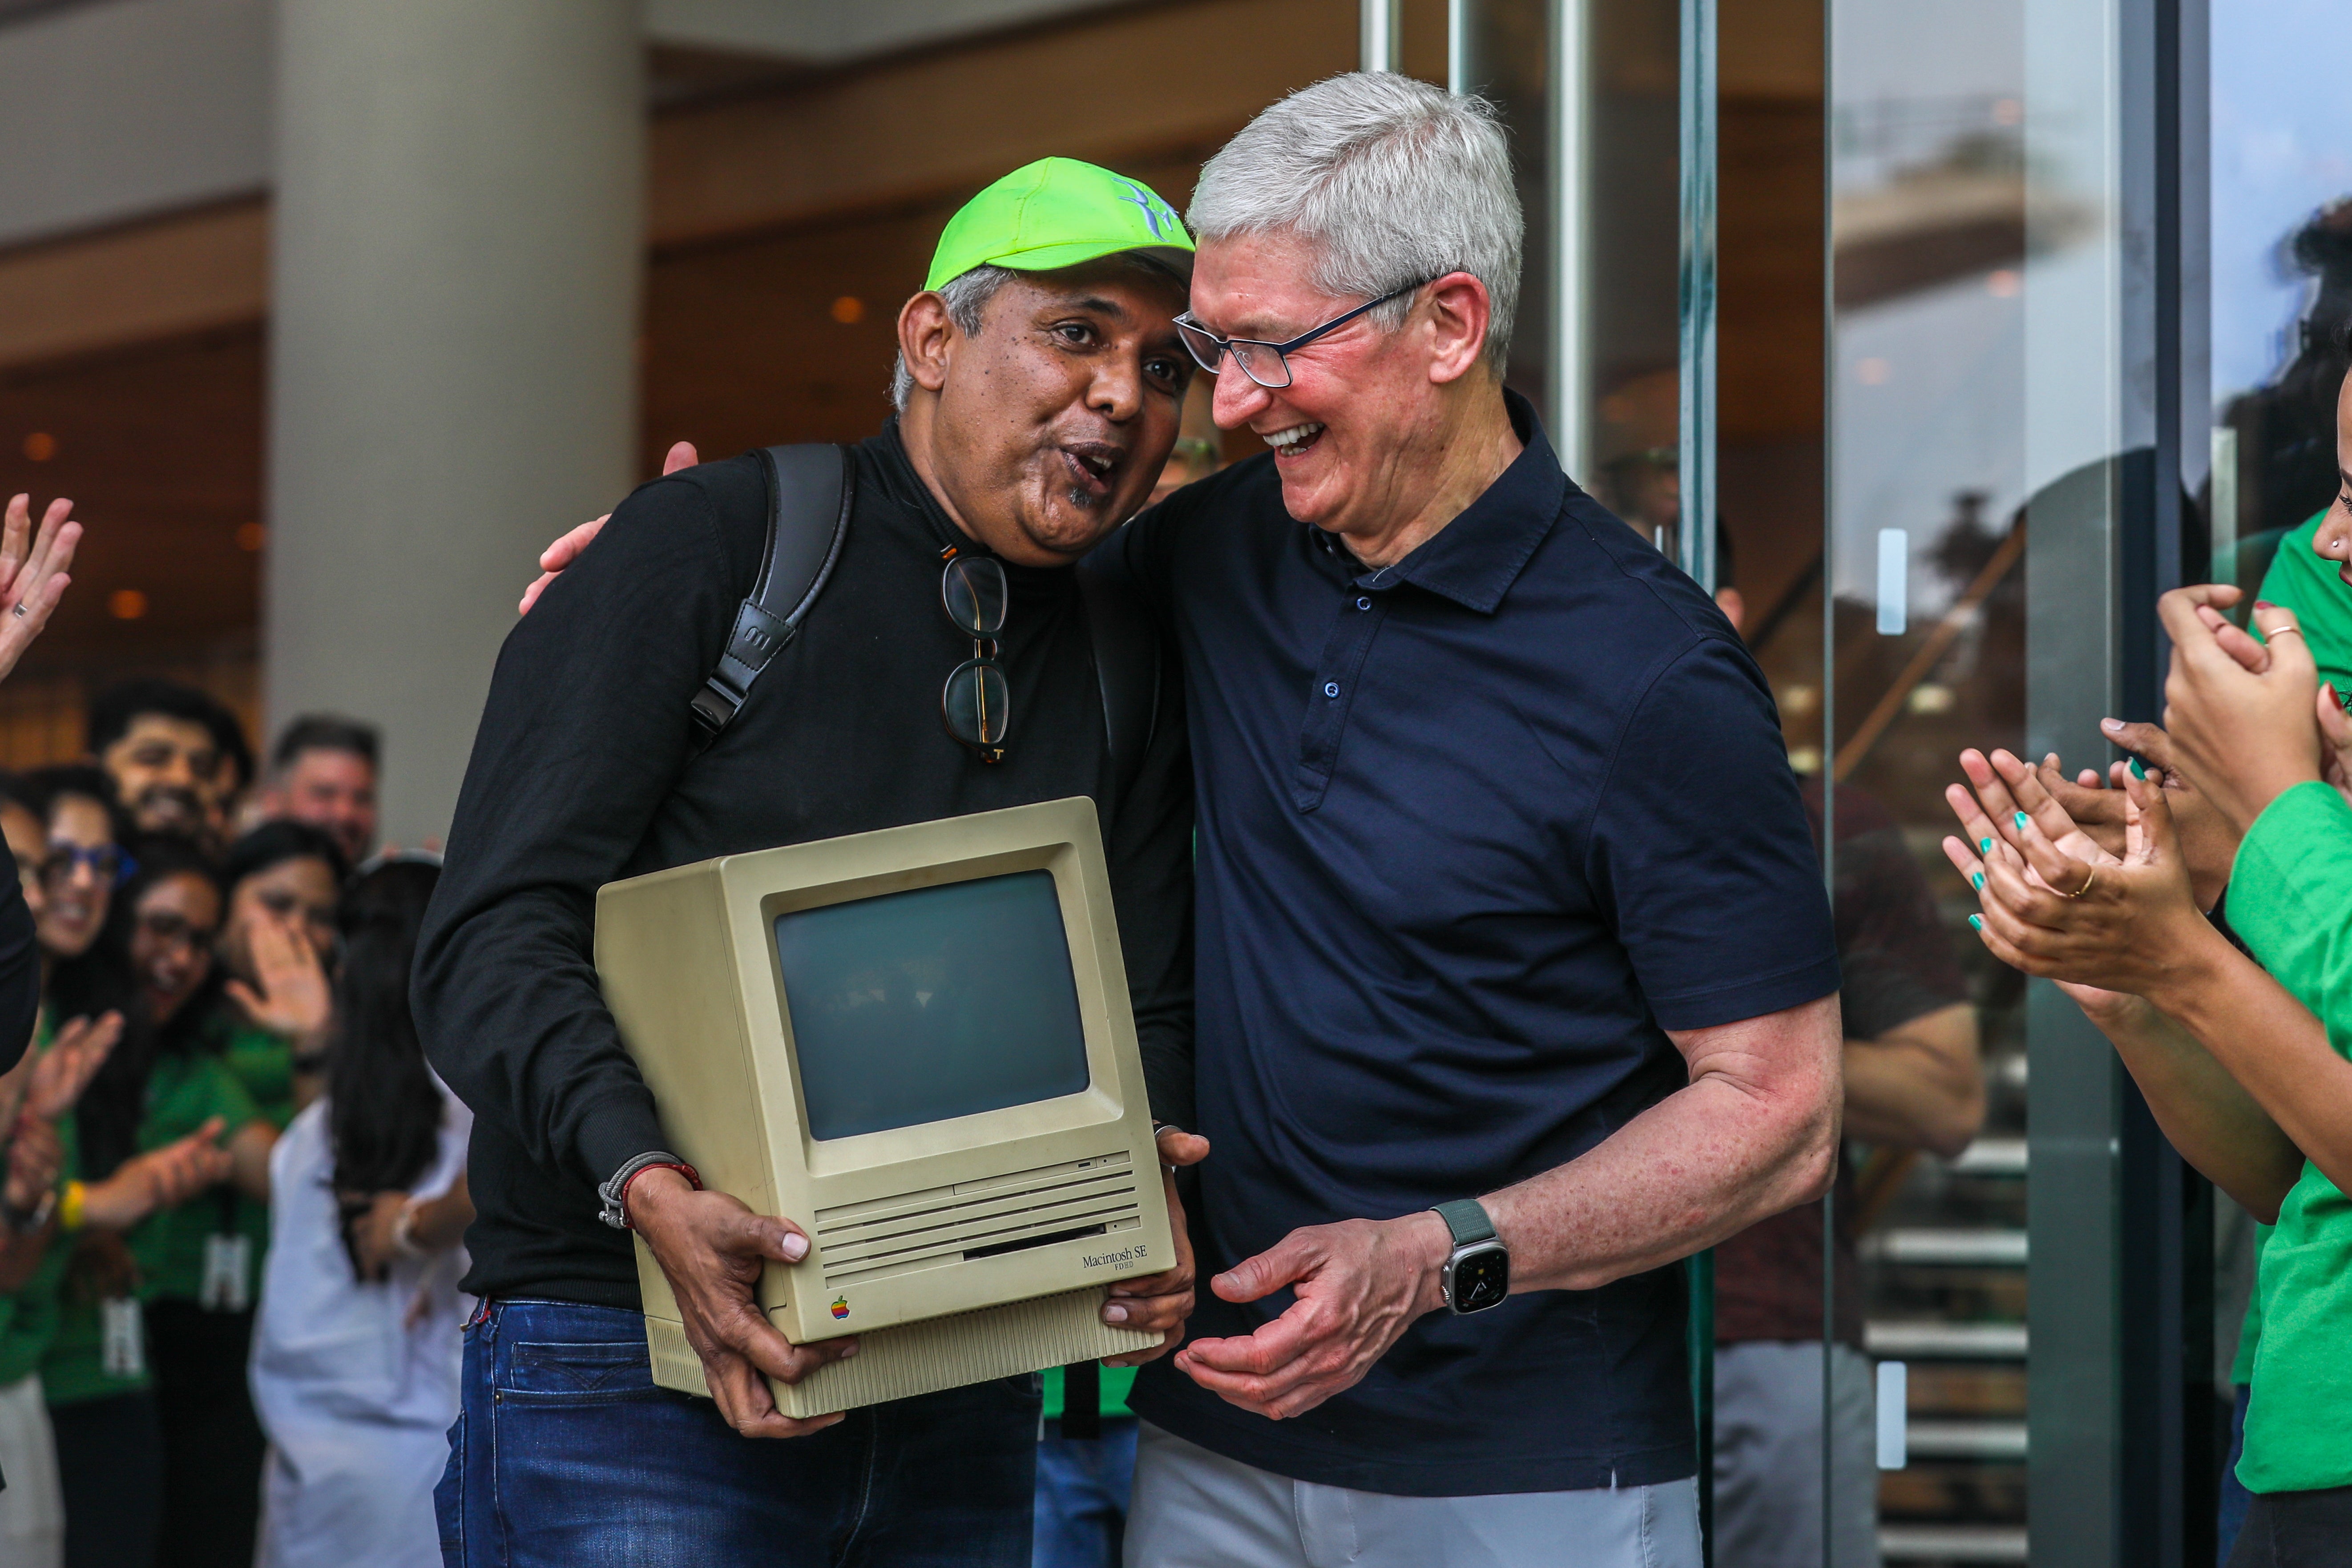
[{"x1": 414, "y1": 426, "x2": 1193, "y2": 1307}]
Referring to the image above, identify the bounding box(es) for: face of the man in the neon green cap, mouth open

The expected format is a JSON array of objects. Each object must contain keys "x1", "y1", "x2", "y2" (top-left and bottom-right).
[{"x1": 899, "y1": 258, "x2": 1193, "y2": 567}]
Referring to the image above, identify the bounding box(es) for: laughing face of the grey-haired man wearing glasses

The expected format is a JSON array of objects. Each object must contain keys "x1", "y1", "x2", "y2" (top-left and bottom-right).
[{"x1": 1193, "y1": 233, "x2": 1493, "y2": 552}]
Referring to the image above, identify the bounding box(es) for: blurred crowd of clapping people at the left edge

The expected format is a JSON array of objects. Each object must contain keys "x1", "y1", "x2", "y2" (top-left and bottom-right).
[{"x1": 0, "y1": 496, "x2": 473, "y2": 1568}]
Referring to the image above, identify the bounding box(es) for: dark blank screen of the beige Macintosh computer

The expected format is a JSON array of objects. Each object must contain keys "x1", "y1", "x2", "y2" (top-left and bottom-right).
[{"x1": 776, "y1": 870, "x2": 1087, "y2": 1138}]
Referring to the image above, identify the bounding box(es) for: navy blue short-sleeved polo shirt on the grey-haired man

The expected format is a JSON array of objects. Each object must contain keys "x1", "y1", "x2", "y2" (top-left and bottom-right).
[{"x1": 1105, "y1": 397, "x2": 1837, "y2": 1497}]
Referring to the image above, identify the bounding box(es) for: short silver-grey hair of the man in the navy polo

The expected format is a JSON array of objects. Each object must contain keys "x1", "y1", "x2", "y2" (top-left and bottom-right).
[{"x1": 1186, "y1": 71, "x2": 1526, "y2": 376}]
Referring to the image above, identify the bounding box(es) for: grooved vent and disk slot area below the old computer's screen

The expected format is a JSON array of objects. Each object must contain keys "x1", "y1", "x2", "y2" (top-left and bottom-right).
[{"x1": 816, "y1": 1152, "x2": 1141, "y2": 1288}]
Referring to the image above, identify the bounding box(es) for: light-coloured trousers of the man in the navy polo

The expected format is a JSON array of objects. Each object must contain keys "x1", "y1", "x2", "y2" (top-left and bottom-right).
[{"x1": 1126, "y1": 1422, "x2": 1698, "y2": 1568}]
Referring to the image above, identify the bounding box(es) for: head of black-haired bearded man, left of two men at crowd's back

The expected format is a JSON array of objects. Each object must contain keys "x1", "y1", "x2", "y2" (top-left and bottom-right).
[{"x1": 89, "y1": 679, "x2": 254, "y2": 851}]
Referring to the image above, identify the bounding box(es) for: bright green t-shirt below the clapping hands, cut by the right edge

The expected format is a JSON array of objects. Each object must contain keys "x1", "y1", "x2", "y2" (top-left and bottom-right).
[{"x1": 2230, "y1": 785, "x2": 2352, "y2": 1493}]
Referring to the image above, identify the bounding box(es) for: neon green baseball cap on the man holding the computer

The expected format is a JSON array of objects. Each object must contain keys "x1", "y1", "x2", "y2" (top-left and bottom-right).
[{"x1": 922, "y1": 157, "x2": 1193, "y2": 289}]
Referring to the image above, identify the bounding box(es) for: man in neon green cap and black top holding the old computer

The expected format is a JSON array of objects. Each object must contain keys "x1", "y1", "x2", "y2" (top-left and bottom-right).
[{"x1": 414, "y1": 157, "x2": 1204, "y2": 1568}]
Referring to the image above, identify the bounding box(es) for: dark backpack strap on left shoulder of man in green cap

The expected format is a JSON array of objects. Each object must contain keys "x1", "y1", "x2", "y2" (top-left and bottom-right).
[{"x1": 694, "y1": 444, "x2": 856, "y2": 752}]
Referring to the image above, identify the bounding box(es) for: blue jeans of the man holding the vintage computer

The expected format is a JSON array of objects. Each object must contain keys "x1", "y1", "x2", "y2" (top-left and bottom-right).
[{"x1": 433, "y1": 1300, "x2": 1040, "y2": 1568}]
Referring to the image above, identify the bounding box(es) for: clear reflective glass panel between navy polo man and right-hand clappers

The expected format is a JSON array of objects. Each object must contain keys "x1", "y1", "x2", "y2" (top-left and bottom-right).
[{"x1": 1825, "y1": 0, "x2": 2032, "y2": 1563}]
